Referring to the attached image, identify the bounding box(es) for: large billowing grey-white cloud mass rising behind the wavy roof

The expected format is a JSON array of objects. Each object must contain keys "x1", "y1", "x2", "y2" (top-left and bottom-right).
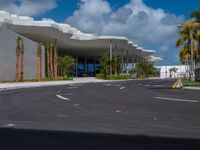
[{"x1": 66, "y1": 0, "x2": 184, "y2": 62}]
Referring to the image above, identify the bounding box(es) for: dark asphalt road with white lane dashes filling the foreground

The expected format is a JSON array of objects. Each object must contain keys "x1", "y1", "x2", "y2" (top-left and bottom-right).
[{"x1": 0, "y1": 80, "x2": 200, "y2": 149}]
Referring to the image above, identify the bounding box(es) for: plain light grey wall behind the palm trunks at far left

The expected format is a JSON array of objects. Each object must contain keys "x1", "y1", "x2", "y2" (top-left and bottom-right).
[{"x1": 0, "y1": 27, "x2": 45, "y2": 80}]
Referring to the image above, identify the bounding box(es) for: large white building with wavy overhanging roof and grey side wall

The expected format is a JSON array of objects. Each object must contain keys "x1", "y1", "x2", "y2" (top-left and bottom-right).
[{"x1": 0, "y1": 11, "x2": 161, "y2": 80}]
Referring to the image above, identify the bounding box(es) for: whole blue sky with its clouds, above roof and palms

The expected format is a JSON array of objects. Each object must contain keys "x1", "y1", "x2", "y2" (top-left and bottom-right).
[{"x1": 0, "y1": 0, "x2": 200, "y2": 65}]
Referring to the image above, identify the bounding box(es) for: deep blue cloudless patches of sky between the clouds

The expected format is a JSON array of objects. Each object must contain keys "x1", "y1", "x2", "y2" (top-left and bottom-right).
[{"x1": 34, "y1": 0, "x2": 200, "y2": 22}]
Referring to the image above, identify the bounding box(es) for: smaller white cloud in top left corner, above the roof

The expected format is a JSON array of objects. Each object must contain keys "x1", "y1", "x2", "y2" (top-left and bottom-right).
[{"x1": 0, "y1": 0, "x2": 57, "y2": 16}]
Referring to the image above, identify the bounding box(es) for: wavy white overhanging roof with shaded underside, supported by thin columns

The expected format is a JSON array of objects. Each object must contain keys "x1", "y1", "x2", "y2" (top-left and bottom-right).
[{"x1": 0, "y1": 11, "x2": 161, "y2": 61}]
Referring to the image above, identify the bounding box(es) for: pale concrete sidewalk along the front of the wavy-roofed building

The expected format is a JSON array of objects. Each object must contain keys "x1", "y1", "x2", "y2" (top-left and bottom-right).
[{"x1": 0, "y1": 77, "x2": 114, "y2": 91}]
